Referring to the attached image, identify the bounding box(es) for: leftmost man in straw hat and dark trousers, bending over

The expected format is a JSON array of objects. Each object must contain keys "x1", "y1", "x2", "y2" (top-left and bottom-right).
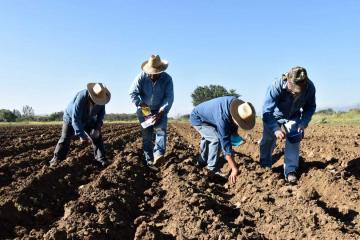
[{"x1": 50, "y1": 83, "x2": 111, "y2": 166}]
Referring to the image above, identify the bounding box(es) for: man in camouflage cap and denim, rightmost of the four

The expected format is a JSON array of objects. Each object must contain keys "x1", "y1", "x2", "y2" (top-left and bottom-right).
[{"x1": 260, "y1": 66, "x2": 316, "y2": 183}]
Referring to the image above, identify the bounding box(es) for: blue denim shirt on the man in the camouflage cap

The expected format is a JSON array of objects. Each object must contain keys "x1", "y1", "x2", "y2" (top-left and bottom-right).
[{"x1": 263, "y1": 79, "x2": 316, "y2": 132}]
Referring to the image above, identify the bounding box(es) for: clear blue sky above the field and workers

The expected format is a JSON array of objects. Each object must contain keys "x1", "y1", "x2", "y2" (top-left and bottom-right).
[{"x1": 0, "y1": 0, "x2": 360, "y2": 116}]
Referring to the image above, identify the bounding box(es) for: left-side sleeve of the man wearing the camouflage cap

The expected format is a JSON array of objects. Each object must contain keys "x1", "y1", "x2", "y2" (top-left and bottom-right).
[{"x1": 263, "y1": 81, "x2": 281, "y2": 132}]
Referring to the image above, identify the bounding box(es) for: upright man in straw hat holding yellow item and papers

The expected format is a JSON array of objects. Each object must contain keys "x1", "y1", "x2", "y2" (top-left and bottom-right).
[{"x1": 129, "y1": 55, "x2": 174, "y2": 168}]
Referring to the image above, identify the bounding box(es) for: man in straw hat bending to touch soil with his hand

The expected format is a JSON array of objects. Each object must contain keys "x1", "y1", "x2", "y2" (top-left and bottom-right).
[{"x1": 190, "y1": 96, "x2": 256, "y2": 183}]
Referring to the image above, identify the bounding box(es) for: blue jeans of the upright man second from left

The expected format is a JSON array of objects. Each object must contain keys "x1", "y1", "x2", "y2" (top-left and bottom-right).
[{"x1": 136, "y1": 109, "x2": 168, "y2": 162}]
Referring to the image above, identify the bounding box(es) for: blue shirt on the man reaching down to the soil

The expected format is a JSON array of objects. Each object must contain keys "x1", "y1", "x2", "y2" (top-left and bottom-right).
[{"x1": 190, "y1": 96, "x2": 238, "y2": 155}]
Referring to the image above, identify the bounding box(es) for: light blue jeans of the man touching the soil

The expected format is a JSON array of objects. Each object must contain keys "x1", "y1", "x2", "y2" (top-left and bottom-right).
[{"x1": 193, "y1": 125, "x2": 221, "y2": 171}]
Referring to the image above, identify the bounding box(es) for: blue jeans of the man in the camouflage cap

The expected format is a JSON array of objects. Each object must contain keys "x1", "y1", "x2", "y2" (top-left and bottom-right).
[{"x1": 260, "y1": 123, "x2": 300, "y2": 178}]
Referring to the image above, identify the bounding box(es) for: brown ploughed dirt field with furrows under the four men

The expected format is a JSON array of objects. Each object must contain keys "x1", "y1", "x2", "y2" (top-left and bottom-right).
[{"x1": 0, "y1": 123, "x2": 360, "y2": 239}]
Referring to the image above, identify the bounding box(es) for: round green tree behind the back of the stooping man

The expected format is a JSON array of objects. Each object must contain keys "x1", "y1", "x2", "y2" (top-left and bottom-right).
[{"x1": 191, "y1": 85, "x2": 240, "y2": 106}]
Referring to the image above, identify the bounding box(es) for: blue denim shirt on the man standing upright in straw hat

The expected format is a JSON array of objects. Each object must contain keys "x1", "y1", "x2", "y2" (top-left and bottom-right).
[{"x1": 129, "y1": 72, "x2": 174, "y2": 114}]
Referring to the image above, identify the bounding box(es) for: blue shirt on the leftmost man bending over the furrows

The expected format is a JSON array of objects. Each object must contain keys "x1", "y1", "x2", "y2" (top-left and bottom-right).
[{"x1": 64, "y1": 89, "x2": 105, "y2": 138}]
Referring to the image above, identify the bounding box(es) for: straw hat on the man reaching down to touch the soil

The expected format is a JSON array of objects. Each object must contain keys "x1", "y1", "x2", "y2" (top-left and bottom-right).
[{"x1": 230, "y1": 99, "x2": 256, "y2": 130}]
